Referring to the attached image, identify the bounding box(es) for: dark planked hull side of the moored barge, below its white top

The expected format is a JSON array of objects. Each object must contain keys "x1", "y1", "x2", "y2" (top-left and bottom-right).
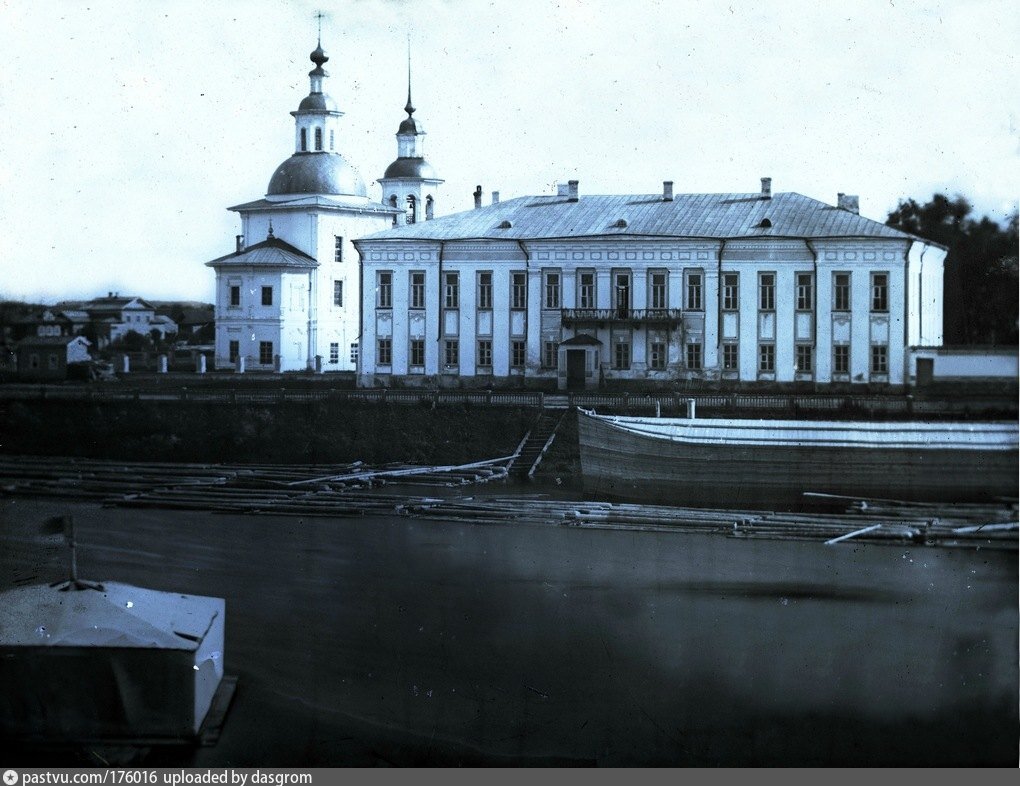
[{"x1": 578, "y1": 413, "x2": 1018, "y2": 509}]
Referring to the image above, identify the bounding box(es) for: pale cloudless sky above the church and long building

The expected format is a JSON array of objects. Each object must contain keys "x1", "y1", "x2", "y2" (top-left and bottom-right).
[{"x1": 0, "y1": 0, "x2": 1020, "y2": 303}]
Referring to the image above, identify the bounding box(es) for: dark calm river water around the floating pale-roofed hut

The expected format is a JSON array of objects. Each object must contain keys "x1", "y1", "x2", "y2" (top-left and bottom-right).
[{"x1": 0, "y1": 492, "x2": 1020, "y2": 767}]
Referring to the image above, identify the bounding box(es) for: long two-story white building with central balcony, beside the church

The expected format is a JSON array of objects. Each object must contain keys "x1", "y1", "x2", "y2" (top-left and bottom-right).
[{"x1": 355, "y1": 177, "x2": 946, "y2": 389}]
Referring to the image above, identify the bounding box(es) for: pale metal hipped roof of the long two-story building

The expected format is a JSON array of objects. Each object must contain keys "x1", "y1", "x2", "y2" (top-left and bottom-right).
[{"x1": 362, "y1": 193, "x2": 926, "y2": 241}]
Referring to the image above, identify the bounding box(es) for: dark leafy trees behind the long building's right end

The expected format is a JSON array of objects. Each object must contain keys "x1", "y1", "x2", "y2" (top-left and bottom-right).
[{"x1": 885, "y1": 194, "x2": 1018, "y2": 345}]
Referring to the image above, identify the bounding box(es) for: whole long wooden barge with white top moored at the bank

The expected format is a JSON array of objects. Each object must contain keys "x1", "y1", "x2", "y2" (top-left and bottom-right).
[{"x1": 577, "y1": 411, "x2": 1018, "y2": 508}]
